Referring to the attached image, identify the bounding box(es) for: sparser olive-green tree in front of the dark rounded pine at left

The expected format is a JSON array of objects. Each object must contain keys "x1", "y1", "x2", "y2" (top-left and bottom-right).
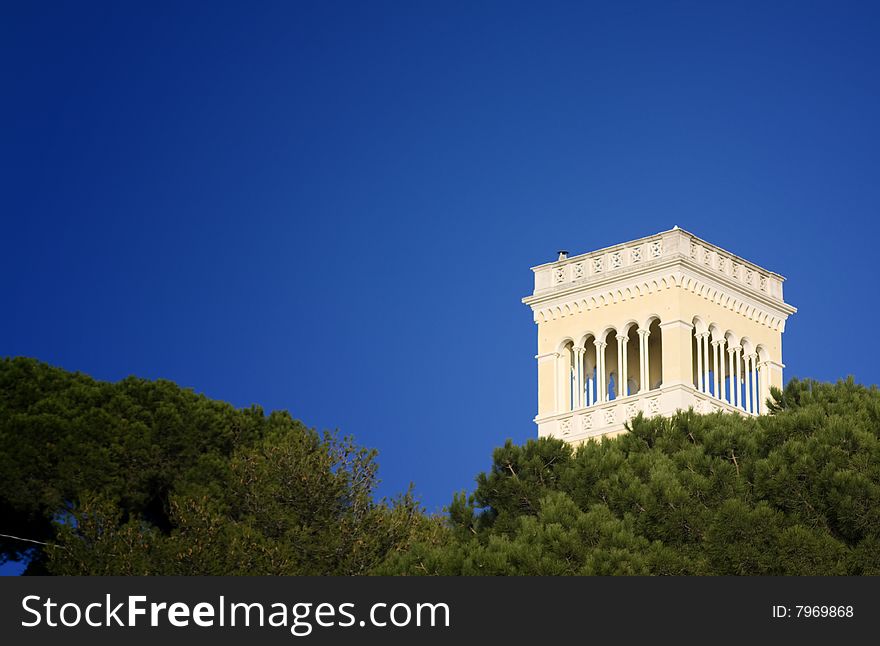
[{"x1": 49, "y1": 428, "x2": 425, "y2": 575}]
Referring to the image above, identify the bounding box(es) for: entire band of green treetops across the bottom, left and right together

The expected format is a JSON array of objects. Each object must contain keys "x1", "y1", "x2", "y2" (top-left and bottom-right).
[{"x1": 0, "y1": 358, "x2": 880, "y2": 575}]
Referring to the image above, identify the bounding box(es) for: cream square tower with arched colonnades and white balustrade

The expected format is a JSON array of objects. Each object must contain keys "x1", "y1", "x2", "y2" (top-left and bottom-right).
[{"x1": 523, "y1": 227, "x2": 796, "y2": 442}]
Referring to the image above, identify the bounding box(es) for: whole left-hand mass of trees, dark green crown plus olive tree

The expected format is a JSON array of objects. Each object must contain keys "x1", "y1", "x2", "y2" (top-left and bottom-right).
[{"x1": 0, "y1": 358, "x2": 426, "y2": 575}]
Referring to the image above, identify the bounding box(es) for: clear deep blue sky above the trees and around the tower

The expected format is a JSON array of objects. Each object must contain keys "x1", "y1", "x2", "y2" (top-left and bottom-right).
[{"x1": 0, "y1": 0, "x2": 880, "y2": 576}]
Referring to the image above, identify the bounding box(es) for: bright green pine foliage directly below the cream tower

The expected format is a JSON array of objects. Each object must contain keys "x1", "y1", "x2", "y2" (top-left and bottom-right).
[{"x1": 379, "y1": 379, "x2": 880, "y2": 575}]
